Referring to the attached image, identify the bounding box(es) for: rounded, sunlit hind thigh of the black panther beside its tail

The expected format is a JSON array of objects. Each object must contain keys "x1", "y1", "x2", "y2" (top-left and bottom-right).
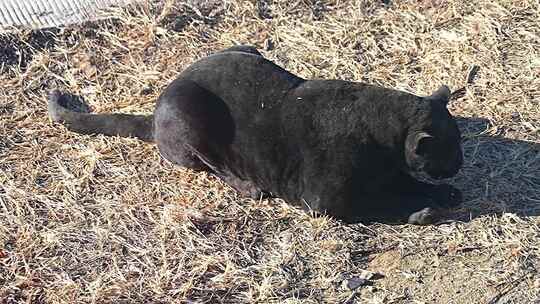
[{"x1": 154, "y1": 79, "x2": 234, "y2": 172}]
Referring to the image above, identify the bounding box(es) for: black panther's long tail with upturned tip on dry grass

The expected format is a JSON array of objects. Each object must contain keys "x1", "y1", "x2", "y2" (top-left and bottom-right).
[{"x1": 47, "y1": 90, "x2": 154, "y2": 141}]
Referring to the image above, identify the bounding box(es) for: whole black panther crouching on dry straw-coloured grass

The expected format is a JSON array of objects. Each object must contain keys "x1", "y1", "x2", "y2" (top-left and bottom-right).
[{"x1": 49, "y1": 46, "x2": 462, "y2": 224}]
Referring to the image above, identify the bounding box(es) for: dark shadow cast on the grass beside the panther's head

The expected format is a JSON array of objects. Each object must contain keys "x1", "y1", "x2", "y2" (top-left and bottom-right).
[{"x1": 440, "y1": 117, "x2": 540, "y2": 221}]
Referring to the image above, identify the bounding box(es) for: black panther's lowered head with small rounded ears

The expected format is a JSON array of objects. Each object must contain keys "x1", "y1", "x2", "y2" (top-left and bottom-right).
[{"x1": 405, "y1": 86, "x2": 463, "y2": 179}]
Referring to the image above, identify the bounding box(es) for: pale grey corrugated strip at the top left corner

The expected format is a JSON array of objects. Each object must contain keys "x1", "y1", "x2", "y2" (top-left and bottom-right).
[{"x1": 0, "y1": 0, "x2": 138, "y2": 30}]
